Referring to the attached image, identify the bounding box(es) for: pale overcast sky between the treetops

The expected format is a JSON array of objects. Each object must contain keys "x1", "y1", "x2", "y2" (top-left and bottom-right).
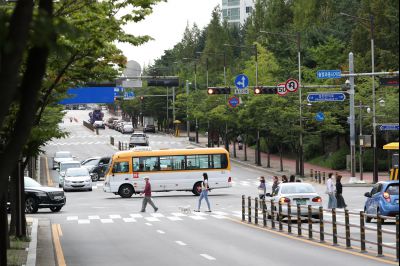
[{"x1": 117, "y1": 0, "x2": 222, "y2": 68}]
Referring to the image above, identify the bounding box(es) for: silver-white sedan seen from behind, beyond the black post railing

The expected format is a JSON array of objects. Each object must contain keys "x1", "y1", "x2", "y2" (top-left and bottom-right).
[{"x1": 267, "y1": 183, "x2": 322, "y2": 218}]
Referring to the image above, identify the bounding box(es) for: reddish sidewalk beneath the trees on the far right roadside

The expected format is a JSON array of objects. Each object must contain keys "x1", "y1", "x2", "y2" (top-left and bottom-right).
[{"x1": 191, "y1": 135, "x2": 388, "y2": 186}]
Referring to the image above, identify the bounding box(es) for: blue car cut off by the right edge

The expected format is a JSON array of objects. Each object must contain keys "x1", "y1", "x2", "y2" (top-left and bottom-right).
[{"x1": 364, "y1": 180, "x2": 399, "y2": 223}]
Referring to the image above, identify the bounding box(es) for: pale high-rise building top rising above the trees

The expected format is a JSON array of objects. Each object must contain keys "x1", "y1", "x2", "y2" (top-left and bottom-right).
[{"x1": 222, "y1": 0, "x2": 254, "y2": 26}]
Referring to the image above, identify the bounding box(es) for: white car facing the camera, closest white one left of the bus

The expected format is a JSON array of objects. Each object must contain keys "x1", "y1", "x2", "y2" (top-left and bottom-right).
[{"x1": 63, "y1": 167, "x2": 92, "y2": 191}]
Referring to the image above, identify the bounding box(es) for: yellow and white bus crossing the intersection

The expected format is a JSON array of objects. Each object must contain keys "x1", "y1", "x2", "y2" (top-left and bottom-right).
[{"x1": 103, "y1": 147, "x2": 232, "y2": 198}]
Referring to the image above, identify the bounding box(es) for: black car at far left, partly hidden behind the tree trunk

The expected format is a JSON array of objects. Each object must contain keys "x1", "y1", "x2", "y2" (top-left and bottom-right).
[{"x1": 24, "y1": 176, "x2": 66, "y2": 213}]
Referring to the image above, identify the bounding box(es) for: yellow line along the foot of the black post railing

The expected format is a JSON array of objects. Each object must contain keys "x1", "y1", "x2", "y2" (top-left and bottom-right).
[{"x1": 226, "y1": 217, "x2": 398, "y2": 265}]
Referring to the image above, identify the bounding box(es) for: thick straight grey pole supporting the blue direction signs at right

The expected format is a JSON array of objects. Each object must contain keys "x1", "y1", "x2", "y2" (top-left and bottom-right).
[{"x1": 349, "y1": 53, "x2": 356, "y2": 177}]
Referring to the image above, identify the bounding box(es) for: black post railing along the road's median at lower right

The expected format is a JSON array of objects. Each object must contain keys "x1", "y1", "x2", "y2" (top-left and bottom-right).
[{"x1": 242, "y1": 195, "x2": 399, "y2": 261}]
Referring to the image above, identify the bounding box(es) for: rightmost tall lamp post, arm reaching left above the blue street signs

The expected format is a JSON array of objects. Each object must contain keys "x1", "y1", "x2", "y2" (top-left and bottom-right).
[{"x1": 340, "y1": 12, "x2": 378, "y2": 183}]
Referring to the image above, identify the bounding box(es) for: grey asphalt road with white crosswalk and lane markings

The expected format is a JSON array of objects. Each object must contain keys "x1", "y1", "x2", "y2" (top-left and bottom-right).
[{"x1": 28, "y1": 111, "x2": 395, "y2": 266}]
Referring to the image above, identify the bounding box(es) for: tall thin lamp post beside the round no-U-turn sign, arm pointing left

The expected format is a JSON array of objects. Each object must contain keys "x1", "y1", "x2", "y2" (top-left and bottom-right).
[{"x1": 260, "y1": 30, "x2": 304, "y2": 176}]
